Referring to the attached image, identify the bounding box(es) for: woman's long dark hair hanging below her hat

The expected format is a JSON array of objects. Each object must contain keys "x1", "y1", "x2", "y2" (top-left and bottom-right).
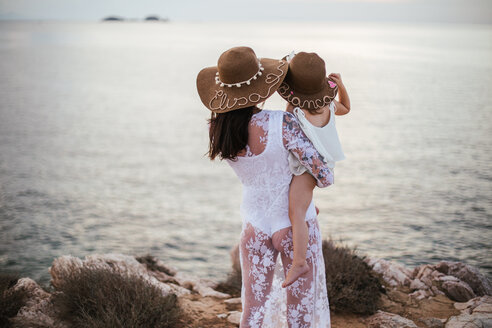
[{"x1": 208, "y1": 106, "x2": 256, "y2": 161}]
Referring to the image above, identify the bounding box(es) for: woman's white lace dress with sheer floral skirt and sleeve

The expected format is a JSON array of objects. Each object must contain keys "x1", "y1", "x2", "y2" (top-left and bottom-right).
[{"x1": 228, "y1": 110, "x2": 333, "y2": 328}]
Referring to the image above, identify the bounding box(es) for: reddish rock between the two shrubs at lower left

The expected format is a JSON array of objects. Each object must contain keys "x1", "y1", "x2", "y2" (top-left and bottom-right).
[{"x1": 10, "y1": 278, "x2": 69, "y2": 328}]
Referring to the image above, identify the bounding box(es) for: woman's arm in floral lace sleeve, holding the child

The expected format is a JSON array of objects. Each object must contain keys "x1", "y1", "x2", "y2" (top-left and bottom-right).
[{"x1": 282, "y1": 112, "x2": 333, "y2": 188}]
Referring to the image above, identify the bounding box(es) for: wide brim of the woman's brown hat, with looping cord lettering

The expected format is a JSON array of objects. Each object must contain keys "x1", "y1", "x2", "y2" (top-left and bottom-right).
[{"x1": 196, "y1": 58, "x2": 289, "y2": 113}]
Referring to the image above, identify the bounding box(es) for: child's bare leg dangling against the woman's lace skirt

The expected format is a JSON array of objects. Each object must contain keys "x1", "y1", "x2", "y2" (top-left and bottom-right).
[{"x1": 282, "y1": 173, "x2": 316, "y2": 287}]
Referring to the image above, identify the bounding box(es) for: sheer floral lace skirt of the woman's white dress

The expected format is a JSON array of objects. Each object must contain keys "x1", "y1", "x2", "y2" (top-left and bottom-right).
[{"x1": 240, "y1": 219, "x2": 330, "y2": 328}]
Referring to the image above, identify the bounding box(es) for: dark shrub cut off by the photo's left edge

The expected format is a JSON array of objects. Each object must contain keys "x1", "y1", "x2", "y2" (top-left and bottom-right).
[{"x1": 0, "y1": 273, "x2": 28, "y2": 327}]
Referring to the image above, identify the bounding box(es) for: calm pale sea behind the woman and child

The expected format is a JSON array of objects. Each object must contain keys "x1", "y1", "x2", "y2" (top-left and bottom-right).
[{"x1": 0, "y1": 21, "x2": 492, "y2": 284}]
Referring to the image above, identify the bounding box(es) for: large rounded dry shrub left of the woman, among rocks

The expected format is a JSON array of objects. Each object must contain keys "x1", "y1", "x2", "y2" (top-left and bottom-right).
[{"x1": 53, "y1": 267, "x2": 181, "y2": 328}]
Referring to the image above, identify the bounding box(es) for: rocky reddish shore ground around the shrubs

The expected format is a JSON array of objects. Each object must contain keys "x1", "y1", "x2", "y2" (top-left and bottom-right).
[{"x1": 7, "y1": 254, "x2": 492, "y2": 328}]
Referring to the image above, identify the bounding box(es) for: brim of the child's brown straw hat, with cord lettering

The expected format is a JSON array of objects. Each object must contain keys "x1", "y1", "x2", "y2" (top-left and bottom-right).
[{"x1": 277, "y1": 77, "x2": 338, "y2": 110}]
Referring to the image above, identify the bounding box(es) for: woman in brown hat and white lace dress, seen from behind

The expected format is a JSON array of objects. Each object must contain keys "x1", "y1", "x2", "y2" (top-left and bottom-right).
[{"x1": 197, "y1": 47, "x2": 333, "y2": 328}]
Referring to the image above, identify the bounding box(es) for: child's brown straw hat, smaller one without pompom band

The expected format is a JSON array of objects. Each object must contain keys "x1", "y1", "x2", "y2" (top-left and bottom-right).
[{"x1": 277, "y1": 52, "x2": 338, "y2": 110}]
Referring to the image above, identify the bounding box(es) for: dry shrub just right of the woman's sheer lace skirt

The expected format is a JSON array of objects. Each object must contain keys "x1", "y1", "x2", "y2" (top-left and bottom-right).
[{"x1": 323, "y1": 239, "x2": 382, "y2": 314}]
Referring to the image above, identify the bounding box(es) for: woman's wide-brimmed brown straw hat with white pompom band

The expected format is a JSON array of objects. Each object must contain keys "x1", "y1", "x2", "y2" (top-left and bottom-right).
[{"x1": 196, "y1": 47, "x2": 289, "y2": 113}]
